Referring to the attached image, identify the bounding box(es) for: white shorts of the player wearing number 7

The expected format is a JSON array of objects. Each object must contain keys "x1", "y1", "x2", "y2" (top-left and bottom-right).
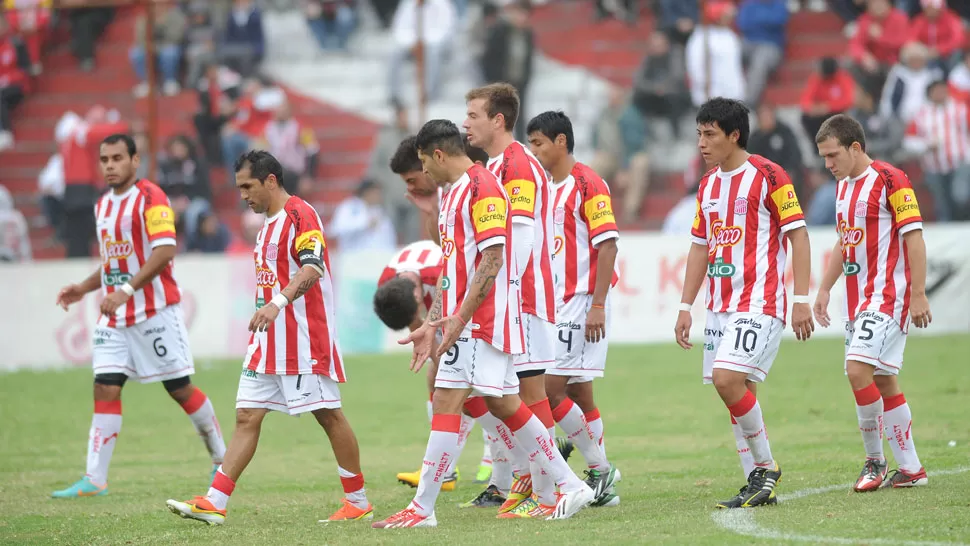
[{"x1": 236, "y1": 367, "x2": 340, "y2": 415}]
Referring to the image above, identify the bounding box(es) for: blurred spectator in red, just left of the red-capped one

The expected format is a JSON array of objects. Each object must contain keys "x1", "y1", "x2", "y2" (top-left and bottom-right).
[{"x1": 849, "y1": 0, "x2": 909, "y2": 96}]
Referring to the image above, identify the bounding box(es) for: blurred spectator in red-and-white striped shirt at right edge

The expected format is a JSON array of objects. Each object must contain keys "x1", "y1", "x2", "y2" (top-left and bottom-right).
[{"x1": 903, "y1": 80, "x2": 970, "y2": 222}]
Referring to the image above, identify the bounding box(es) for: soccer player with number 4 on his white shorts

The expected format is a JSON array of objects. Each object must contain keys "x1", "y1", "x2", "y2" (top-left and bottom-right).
[{"x1": 526, "y1": 112, "x2": 620, "y2": 506}]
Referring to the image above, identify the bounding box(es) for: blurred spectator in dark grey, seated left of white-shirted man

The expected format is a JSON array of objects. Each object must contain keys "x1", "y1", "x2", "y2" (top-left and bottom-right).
[{"x1": 633, "y1": 31, "x2": 690, "y2": 139}]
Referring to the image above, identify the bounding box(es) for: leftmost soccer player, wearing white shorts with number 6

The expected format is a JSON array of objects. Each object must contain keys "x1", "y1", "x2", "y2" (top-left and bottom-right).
[{"x1": 53, "y1": 134, "x2": 226, "y2": 498}]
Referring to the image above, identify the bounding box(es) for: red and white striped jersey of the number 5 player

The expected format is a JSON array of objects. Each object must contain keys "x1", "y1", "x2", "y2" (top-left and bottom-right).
[{"x1": 835, "y1": 157, "x2": 923, "y2": 331}]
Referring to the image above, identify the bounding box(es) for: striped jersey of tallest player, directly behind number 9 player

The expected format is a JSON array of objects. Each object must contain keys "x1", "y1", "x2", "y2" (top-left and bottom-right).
[{"x1": 488, "y1": 142, "x2": 556, "y2": 322}]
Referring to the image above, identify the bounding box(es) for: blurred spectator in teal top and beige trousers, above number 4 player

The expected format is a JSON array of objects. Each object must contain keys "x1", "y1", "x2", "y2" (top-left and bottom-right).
[{"x1": 590, "y1": 86, "x2": 650, "y2": 222}]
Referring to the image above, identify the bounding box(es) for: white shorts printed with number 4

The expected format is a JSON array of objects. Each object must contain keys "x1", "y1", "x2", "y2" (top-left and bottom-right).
[{"x1": 546, "y1": 294, "x2": 610, "y2": 383}]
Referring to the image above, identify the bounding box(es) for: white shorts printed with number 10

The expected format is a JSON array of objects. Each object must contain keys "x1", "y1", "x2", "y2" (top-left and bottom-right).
[{"x1": 704, "y1": 310, "x2": 785, "y2": 385}]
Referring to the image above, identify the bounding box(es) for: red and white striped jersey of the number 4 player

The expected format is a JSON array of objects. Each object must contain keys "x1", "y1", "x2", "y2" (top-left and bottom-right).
[{"x1": 552, "y1": 161, "x2": 620, "y2": 303}]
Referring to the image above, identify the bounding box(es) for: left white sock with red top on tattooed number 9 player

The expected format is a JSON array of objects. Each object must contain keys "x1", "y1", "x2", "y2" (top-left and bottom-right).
[{"x1": 411, "y1": 414, "x2": 461, "y2": 516}]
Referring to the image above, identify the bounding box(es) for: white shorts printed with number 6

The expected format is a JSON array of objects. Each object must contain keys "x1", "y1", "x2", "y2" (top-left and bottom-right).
[{"x1": 91, "y1": 304, "x2": 195, "y2": 383}]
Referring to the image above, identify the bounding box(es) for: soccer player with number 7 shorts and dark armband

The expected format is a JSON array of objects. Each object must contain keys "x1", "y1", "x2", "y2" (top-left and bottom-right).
[{"x1": 166, "y1": 151, "x2": 374, "y2": 525}]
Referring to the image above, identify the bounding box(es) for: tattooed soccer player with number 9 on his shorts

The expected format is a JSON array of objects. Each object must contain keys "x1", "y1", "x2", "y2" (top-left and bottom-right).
[{"x1": 374, "y1": 120, "x2": 593, "y2": 528}]
